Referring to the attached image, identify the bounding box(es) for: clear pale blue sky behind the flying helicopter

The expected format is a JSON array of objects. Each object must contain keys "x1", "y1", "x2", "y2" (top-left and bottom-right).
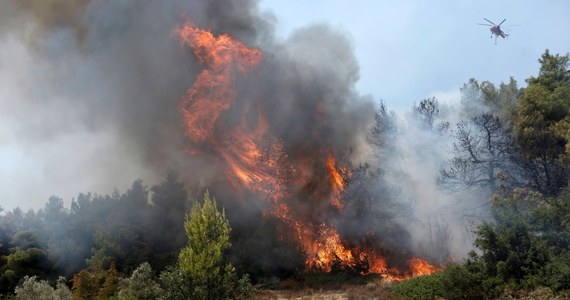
[{"x1": 261, "y1": 0, "x2": 570, "y2": 110}]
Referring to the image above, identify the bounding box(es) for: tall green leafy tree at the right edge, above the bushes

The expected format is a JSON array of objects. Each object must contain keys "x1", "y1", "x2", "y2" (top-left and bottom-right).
[{"x1": 515, "y1": 50, "x2": 570, "y2": 195}]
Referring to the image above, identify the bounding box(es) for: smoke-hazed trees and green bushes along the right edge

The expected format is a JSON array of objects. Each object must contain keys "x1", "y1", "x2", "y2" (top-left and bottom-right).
[{"x1": 394, "y1": 50, "x2": 570, "y2": 299}]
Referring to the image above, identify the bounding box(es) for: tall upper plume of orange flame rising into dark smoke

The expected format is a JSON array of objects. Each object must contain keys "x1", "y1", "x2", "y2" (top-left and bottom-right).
[{"x1": 175, "y1": 22, "x2": 282, "y2": 200}]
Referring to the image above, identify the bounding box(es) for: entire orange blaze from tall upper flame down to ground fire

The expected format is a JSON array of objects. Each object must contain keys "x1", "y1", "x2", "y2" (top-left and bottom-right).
[{"x1": 175, "y1": 22, "x2": 435, "y2": 279}]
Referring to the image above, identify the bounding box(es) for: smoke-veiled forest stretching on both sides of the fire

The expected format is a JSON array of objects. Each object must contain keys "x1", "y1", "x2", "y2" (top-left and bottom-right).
[{"x1": 0, "y1": 50, "x2": 570, "y2": 299}]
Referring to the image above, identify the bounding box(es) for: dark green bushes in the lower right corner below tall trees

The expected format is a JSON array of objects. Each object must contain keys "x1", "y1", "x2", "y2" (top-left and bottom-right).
[{"x1": 444, "y1": 190, "x2": 570, "y2": 298}]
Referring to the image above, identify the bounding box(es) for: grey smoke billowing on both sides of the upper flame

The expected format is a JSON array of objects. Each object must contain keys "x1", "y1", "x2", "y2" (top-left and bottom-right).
[{"x1": 0, "y1": 0, "x2": 371, "y2": 207}]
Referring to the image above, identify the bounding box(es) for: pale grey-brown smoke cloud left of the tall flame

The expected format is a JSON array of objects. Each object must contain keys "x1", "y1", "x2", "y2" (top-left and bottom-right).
[{"x1": 0, "y1": 0, "x2": 272, "y2": 208}]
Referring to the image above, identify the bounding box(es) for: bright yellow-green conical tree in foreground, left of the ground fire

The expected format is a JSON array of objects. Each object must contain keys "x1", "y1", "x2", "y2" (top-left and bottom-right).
[{"x1": 178, "y1": 192, "x2": 250, "y2": 299}]
